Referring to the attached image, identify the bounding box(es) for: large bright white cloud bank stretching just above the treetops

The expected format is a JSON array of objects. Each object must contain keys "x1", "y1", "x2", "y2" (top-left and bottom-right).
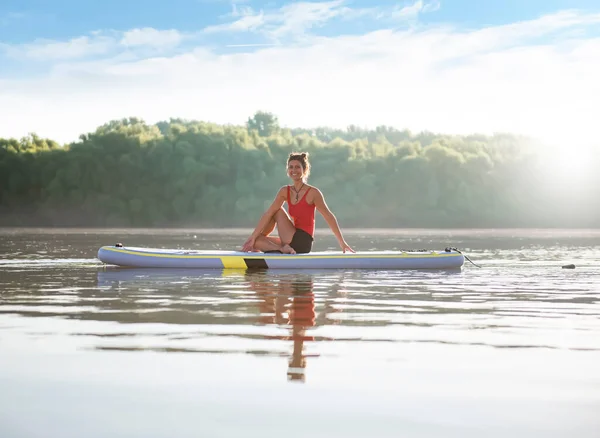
[{"x1": 0, "y1": 6, "x2": 600, "y2": 149}]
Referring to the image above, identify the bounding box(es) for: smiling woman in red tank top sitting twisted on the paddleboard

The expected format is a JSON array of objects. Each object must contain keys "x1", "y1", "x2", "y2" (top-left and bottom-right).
[{"x1": 242, "y1": 152, "x2": 355, "y2": 254}]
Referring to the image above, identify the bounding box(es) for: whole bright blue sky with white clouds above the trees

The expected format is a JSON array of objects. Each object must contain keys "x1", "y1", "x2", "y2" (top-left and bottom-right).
[{"x1": 0, "y1": 0, "x2": 600, "y2": 144}]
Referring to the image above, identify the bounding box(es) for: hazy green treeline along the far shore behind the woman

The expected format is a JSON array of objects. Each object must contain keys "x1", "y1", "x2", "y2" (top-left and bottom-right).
[{"x1": 0, "y1": 112, "x2": 600, "y2": 228}]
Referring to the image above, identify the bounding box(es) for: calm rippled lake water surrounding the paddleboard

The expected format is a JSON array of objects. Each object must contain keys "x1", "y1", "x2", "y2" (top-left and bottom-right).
[{"x1": 0, "y1": 229, "x2": 600, "y2": 438}]
